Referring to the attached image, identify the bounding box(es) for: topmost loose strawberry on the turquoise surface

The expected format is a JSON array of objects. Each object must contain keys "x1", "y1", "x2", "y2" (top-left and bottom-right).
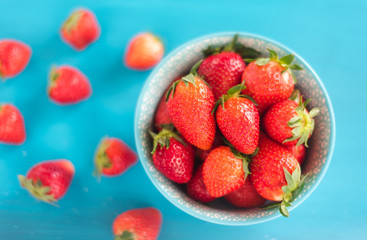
[{"x1": 60, "y1": 9, "x2": 101, "y2": 51}]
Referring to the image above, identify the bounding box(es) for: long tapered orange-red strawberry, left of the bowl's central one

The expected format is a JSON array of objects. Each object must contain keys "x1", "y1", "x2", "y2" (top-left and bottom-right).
[{"x1": 166, "y1": 62, "x2": 215, "y2": 150}]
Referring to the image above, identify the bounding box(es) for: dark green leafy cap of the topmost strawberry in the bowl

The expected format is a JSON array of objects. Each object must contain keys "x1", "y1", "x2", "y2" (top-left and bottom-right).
[{"x1": 203, "y1": 34, "x2": 260, "y2": 58}]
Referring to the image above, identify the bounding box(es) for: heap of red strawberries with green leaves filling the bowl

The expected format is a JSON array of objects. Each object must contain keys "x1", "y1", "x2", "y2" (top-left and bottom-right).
[{"x1": 150, "y1": 36, "x2": 319, "y2": 217}]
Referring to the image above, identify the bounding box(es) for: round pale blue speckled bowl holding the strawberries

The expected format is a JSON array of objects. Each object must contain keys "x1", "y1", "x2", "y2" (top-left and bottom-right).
[{"x1": 135, "y1": 32, "x2": 335, "y2": 225}]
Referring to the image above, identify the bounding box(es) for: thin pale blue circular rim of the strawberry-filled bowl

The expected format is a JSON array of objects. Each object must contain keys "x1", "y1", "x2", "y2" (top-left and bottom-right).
[{"x1": 134, "y1": 32, "x2": 336, "y2": 226}]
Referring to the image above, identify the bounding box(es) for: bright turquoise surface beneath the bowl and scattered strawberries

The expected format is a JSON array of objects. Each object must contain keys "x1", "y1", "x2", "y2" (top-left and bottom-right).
[{"x1": 0, "y1": 0, "x2": 367, "y2": 240}]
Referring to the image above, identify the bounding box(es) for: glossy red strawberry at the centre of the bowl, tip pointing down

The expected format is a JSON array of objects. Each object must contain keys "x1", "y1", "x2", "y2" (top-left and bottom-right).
[{"x1": 213, "y1": 84, "x2": 260, "y2": 154}]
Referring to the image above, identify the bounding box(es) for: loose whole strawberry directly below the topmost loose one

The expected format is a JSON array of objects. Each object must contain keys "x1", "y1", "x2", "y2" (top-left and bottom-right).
[{"x1": 48, "y1": 65, "x2": 92, "y2": 105}]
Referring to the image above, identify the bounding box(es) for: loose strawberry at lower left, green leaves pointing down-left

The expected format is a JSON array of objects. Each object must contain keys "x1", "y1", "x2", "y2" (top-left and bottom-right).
[{"x1": 18, "y1": 159, "x2": 75, "y2": 204}]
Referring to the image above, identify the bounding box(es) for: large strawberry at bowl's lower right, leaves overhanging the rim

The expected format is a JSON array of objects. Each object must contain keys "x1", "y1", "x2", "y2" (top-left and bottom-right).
[{"x1": 250, "y1": 132, "x2": 305, "y2": 217}]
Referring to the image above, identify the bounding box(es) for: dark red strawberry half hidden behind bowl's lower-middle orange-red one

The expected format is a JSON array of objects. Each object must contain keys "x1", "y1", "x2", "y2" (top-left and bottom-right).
[{"x1": 186, "y1": 165, "x2": 215, "y2": 203}]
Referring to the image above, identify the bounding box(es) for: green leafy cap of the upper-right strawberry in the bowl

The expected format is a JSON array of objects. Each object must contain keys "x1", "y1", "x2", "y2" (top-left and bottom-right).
[{"x1": 249, "y1": 48, "x2": 303, "y2": 83}]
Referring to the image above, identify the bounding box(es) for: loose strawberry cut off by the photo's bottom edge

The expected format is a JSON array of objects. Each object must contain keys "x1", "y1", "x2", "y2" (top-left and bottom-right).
[{"x1": 112, "y1": 207, "x2": 162, "y2": 240}]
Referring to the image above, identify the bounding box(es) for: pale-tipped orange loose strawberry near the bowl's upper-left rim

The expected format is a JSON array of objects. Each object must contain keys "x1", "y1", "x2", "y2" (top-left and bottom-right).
[{"x1": 124, "y1": 33, "x2": 164, "y2": 71}]
